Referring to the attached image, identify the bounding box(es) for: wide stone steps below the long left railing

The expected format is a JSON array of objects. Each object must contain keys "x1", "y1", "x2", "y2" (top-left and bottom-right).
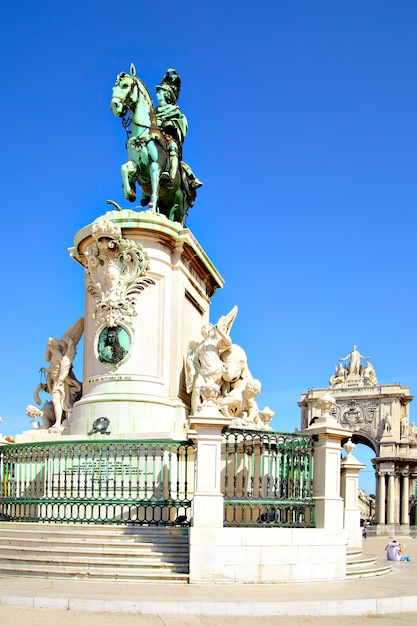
[{"x1": 0, "y1": 522, "x2": 189, "y2": 583}]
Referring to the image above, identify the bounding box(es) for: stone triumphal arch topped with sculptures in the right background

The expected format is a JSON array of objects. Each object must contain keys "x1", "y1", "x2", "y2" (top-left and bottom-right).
[{"x1": 298, "y1": 346, "x2": 417, "y2": 534}]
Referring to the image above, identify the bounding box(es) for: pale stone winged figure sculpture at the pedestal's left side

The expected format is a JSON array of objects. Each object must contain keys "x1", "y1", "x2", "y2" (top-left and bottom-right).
[{"x1": 26, "y1": 318, "x2": 84, "y2": 432}]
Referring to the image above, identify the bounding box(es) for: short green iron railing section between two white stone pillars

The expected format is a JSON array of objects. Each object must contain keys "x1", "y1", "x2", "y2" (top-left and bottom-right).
[{"x1": 223, "y1": 429, "x2": 314, "y2": 528}]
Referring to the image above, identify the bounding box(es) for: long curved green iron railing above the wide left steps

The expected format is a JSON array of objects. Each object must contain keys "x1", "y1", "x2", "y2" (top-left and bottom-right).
[{"x1": 0, "y1": 440, "x2": 194, "y2": 525}]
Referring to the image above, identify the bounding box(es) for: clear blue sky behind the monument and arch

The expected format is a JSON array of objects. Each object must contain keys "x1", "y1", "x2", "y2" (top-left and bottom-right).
[{"x1": 0, "y1": 0, "x2": 417, "y2": 491}]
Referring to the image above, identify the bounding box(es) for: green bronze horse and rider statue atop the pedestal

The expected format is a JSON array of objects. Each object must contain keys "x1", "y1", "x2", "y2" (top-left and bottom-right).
[{"x1": 110, "y1": 64, "x2": 202, "y2": 224}]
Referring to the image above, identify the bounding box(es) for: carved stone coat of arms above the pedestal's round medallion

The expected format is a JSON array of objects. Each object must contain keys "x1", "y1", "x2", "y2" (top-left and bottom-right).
[{"x1": 83, "y1": 217, "x2": 155, "y2": 328}]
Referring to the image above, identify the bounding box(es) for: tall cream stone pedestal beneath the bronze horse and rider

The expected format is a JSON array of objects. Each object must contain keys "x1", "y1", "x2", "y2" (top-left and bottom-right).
[{"x1": 64, "y1": 209, "x2": 223, "y2": 439}]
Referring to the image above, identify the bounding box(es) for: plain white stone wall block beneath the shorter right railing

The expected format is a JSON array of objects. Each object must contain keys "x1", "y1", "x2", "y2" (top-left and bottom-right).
[{"x1": 189, "y1": 527, "x2": 347, "y2": 584}]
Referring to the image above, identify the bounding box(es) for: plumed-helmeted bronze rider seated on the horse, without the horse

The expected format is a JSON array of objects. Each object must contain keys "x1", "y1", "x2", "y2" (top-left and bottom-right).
[{"x1": 155, "y1": 68, "x2": 203, "y2": 190}]
